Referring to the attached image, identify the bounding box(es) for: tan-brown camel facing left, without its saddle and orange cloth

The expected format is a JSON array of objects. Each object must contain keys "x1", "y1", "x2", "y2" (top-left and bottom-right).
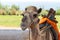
[{"x1": 21, "y1": 6, "x2": 57, "y2": 40}]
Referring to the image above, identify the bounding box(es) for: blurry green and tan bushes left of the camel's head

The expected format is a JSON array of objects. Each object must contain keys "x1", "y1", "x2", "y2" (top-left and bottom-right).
[{"x1": 0, "y1": 4, "x2": 21, "y2": 15}]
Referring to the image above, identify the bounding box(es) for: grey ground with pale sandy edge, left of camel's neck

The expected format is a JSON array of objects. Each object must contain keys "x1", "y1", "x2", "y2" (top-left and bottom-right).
[{"x1": 0, "y1": 26, "x2": 29, "y2": 40}]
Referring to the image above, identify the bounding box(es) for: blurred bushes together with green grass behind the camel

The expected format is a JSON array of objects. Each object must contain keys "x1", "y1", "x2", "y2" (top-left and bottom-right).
[{"x1": 0, "y1": 3, "x2": 60, "y2": 28}]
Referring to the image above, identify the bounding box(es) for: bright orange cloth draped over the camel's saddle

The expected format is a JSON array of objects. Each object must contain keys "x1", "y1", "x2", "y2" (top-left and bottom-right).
[{"x1": 39, "y1": 17, "x2": 59, "y2": 40}]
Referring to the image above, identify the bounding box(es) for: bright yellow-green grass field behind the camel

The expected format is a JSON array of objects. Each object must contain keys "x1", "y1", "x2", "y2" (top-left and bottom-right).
[{"x1": 0, "y1": 15, "x2": 60, "y2": 28}]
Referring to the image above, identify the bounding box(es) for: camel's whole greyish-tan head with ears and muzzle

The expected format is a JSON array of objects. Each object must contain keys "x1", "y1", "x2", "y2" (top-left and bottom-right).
[{"x1": 21, "y1": 6, "x2": 42, "y2": 30}]
